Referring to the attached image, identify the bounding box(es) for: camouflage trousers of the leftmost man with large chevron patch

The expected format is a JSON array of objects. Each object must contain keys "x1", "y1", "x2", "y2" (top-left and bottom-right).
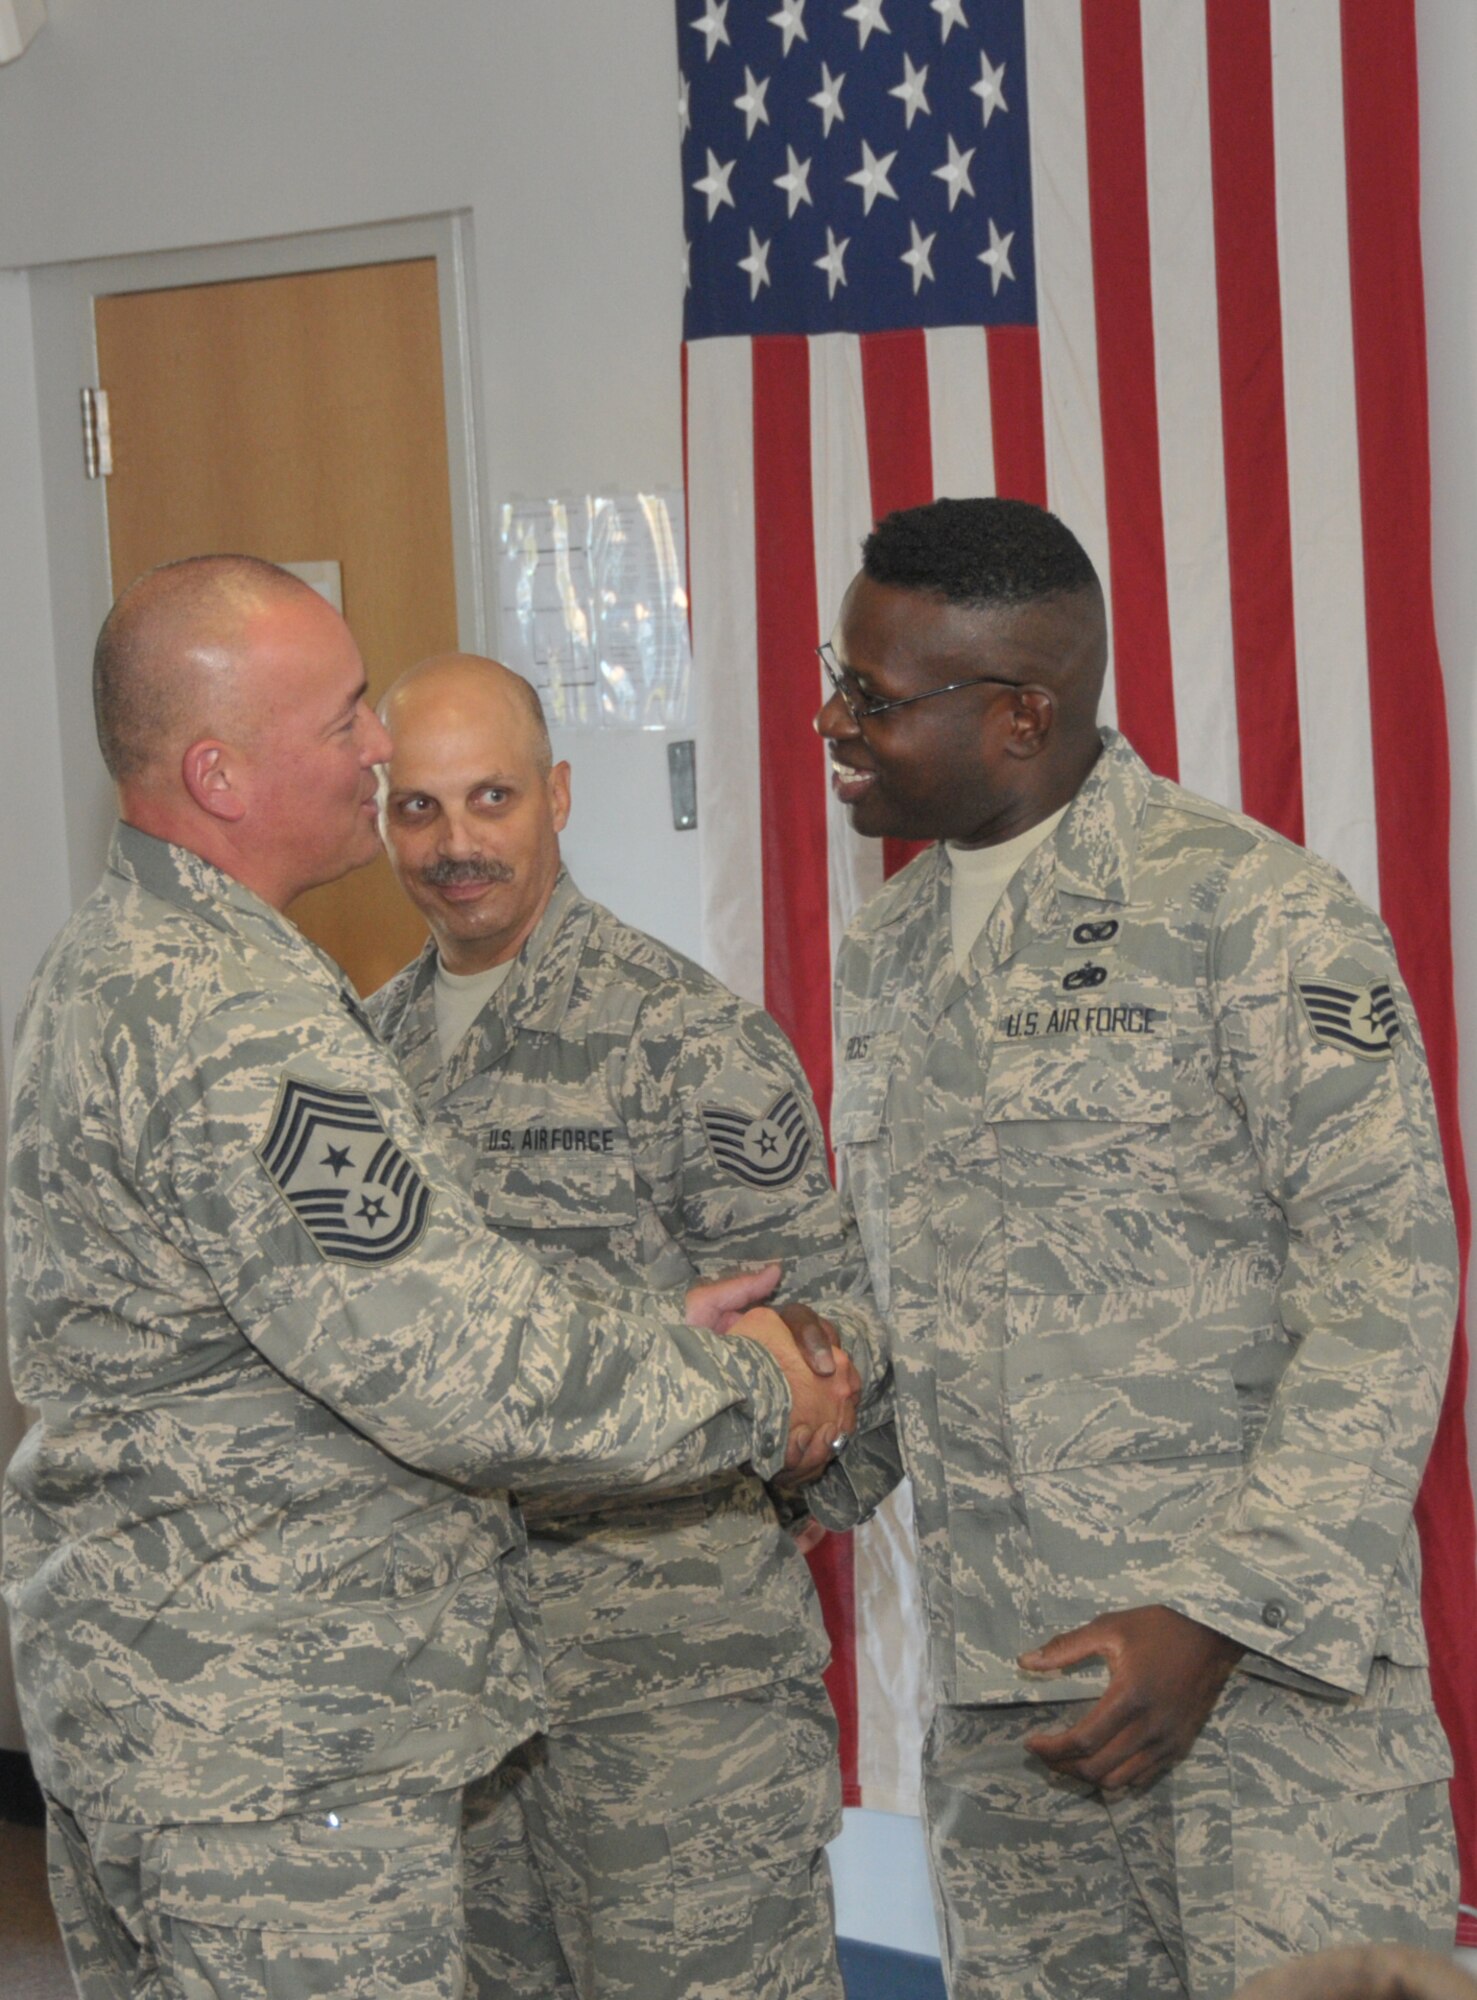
[{"x1": 48, "y1": 1792, "x2": 466, "y2": 2000}]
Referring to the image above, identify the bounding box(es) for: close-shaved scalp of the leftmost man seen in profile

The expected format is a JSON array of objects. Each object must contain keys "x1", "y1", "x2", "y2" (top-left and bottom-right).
[{"x1": 92, "y1": 556, "x2": 318, "y2": 786}]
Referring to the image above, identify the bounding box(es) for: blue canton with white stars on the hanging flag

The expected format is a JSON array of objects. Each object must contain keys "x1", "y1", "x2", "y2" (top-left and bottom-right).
[{"x1": 676, "y1": 0, "x2": 1037, "y2": 340}]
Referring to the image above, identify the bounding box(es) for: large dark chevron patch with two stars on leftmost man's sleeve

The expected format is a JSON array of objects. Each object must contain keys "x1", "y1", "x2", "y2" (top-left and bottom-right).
[{"x1": 256, "y1": 1076, "x2": 430, "y2": 1264}]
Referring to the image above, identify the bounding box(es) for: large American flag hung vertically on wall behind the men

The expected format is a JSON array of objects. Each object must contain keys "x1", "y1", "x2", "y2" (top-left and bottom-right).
[{"x1": 676, "y1": 0, "x2": 1477, "y2": 1942}]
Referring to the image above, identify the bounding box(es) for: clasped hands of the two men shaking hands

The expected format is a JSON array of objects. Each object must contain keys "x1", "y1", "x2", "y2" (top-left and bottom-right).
[{"x1": 686, "y1": 1264, "x2": 861, "y2": 1486}]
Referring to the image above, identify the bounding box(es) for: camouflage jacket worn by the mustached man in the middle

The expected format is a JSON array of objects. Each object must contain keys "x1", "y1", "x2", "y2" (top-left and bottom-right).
[{"x1": 370, "y1": 874, "x2": 879, "y2": 1724}]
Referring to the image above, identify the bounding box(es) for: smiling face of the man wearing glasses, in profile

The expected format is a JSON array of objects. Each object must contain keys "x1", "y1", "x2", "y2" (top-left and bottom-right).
[{"x1": 815, "y1": 574, "x2": 1101, "y2": 846}]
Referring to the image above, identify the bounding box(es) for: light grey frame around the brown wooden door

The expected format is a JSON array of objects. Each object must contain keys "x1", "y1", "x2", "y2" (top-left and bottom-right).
[{"x1": 28, "y1": 212, "x2": 490, "y2": 902}]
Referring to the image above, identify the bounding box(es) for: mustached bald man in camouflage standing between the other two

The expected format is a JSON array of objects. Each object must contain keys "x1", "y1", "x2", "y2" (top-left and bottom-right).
[{"x1": 372, "y1": 656, "x2": 875, "y2": 2000}]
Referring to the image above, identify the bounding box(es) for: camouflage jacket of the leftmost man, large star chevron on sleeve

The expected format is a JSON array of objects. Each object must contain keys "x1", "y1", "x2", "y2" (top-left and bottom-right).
[{"x1": 4, "y1": 828, "x2": 789, "y2": 1824}]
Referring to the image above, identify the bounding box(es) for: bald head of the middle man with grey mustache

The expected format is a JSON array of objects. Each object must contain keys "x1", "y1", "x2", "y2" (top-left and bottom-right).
[{"x1": 380, "y1": 656, "x2": 568, "y2": 972}]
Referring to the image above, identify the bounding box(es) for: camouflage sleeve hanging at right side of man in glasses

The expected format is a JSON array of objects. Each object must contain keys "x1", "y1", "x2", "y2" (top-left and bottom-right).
[{"x1": 1165, "y1": 850, "x2": 1457, "y2": 1692}]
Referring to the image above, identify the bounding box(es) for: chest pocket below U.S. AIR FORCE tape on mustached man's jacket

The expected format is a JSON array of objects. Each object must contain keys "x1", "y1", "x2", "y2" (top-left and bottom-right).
[{"x1": 474, "y1": 1124, "x2": 638, "y2": 1256}]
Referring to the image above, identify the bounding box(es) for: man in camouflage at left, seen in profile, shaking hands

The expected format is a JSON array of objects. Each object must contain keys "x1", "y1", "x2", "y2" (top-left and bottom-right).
[{"x1": 4, "y1": 558, "x2": 864, "y2": 2000}]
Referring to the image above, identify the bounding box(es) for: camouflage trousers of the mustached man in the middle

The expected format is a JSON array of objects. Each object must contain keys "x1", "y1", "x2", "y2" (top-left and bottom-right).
[{"x1": 464, "y1": 1680, "x2": 843, "y2": 2000}]
